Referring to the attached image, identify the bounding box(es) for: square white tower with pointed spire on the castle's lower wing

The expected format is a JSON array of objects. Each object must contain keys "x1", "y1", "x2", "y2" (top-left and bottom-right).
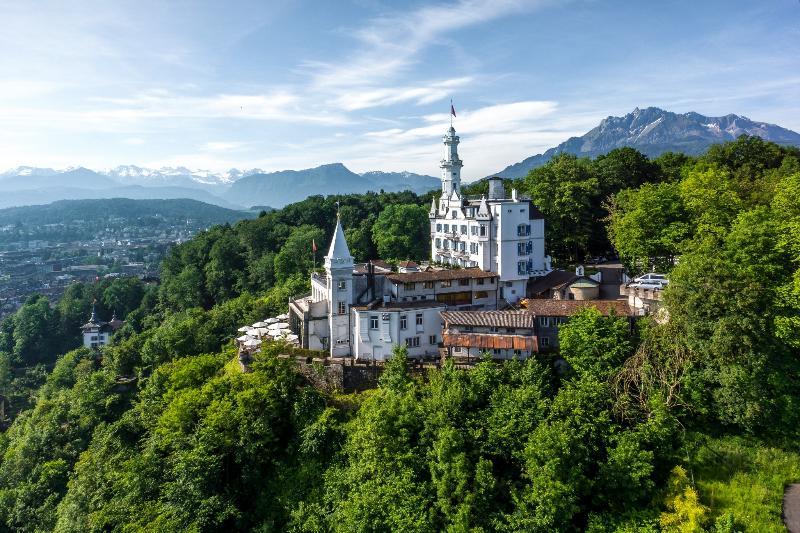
[{"x1": 325, "y1": 217, "x2": 353, "y2": 357}]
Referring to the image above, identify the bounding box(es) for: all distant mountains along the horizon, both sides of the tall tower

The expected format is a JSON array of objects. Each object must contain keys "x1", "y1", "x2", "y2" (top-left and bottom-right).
[{"x1": 0, "y1": 107, "x2": 800, "y2": 209}]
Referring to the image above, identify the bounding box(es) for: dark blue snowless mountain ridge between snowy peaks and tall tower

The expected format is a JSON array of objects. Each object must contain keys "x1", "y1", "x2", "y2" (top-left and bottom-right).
[{"x1": 223, "y1": 163, "x2": 439, "y2": 208}]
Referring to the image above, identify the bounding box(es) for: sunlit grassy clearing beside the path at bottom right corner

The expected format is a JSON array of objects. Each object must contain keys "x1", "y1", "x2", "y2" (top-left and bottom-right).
[{"x1": 688, "y1": 437, "x2": 800, "y2": 533}]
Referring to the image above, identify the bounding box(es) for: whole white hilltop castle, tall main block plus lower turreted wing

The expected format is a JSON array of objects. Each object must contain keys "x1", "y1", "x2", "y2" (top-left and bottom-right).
[{"x1": 289, "y1": 122, "x2": 550, "y2": 361}]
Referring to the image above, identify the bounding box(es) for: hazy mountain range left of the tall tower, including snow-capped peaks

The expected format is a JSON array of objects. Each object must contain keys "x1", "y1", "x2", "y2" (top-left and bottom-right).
[{"x1": 0, "y1": 163, "x2": 439, "y2": 209}]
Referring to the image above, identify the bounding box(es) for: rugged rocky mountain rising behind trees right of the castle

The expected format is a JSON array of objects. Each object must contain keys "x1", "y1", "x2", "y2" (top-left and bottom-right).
[{"x1": 492, "y1": 107, "x2": 800, "y2": 178}]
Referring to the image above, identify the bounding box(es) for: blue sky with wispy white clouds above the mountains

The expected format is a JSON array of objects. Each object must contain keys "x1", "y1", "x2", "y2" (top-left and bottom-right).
[{"x1": 0, "y1": 0, "x2": 800, "y2": 180}]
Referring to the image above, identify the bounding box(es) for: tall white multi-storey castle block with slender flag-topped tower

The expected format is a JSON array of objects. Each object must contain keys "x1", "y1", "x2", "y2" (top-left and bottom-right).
[{"x1": 429, "y1": 126, "x2": 551, "y2": 303}]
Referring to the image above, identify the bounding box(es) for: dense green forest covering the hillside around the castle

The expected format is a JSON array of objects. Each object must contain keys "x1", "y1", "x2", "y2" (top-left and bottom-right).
[{"x1": 0, "y1": 136, "x2": 800, "y2": 533}]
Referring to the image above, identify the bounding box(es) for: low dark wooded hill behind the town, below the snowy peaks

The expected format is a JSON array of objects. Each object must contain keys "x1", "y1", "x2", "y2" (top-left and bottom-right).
[{"x1": 0, "y1": 198, "x2": 255, "y2": 227}]
